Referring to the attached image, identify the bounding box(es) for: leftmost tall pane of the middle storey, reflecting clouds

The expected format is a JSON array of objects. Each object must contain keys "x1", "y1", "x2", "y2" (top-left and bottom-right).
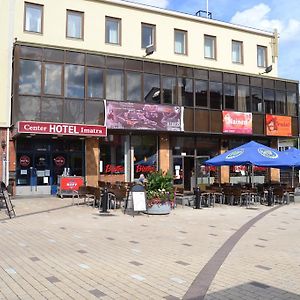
[{"x1": 19, "y1": 60, "x2": 41, "y2": 95}]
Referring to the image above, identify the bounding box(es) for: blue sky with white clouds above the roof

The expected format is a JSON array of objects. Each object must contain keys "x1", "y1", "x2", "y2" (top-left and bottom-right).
[{"x1": 131, "y1": 0, "x2": 300, "y2": 80}]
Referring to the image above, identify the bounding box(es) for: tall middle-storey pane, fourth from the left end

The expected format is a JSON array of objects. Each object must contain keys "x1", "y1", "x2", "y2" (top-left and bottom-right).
[{"x1": 87, "y1": 67, "x2": 103, "y2": 98}]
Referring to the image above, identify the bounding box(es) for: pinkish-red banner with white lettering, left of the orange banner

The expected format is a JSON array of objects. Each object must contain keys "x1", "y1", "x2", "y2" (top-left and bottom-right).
[{"x1": 222, "y1": 111, "x2": 252, "y2": 134}]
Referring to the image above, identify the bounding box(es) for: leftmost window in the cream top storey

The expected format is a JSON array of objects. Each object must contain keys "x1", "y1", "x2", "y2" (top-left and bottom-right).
[{"x1": 24, "y1": 3, "x2": 43, "y2": 33}]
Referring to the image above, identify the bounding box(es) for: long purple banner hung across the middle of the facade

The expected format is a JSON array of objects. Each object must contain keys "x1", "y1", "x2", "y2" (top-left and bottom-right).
[{"x1": 106, "y1": 101, "x2": 183, "y2": 131}]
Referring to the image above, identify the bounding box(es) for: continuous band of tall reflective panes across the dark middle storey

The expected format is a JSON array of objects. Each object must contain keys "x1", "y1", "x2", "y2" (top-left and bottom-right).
[{"x1": 18, "y1": 59, "x2": 297, "y2": 116}]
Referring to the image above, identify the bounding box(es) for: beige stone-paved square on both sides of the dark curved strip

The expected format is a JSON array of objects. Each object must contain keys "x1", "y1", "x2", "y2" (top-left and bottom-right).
[{"x1": 0, "y1": 198, "x2": 300, "y2": 300}]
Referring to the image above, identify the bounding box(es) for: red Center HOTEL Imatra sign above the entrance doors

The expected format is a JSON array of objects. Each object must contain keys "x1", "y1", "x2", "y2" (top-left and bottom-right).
[{"x1": 17, "y1": 121, "x2": 107, "y2": 137}]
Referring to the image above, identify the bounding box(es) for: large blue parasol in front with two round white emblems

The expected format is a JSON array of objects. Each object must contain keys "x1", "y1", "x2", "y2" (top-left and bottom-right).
[{"x1": 204, "y1": 141, "x2": 288, "y2": 168}]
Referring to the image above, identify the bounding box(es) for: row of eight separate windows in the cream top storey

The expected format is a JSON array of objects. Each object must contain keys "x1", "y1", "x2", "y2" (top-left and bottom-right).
[{"x1": 24, "y1": 3, "x2": 267, "y2": 68}]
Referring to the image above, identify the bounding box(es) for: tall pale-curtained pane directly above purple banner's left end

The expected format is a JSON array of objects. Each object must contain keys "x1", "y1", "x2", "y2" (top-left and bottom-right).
[{"x1": 106, "y1": 70, "x2": 124, "y2": 101}]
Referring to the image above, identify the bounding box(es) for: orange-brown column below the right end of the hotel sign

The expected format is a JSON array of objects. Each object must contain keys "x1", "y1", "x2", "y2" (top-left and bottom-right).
[{"x1": 85, "y1": 138, "x2": 100, "y2": 186}]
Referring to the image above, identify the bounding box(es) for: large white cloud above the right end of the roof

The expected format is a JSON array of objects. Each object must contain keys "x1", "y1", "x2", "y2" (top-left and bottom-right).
[{"x1": 230, "y1": 3, "x2": 300, "y2": 41}]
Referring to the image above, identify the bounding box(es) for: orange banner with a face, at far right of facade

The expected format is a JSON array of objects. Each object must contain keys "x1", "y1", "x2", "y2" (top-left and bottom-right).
[{"x1": 266, "y1": 115, "x2": 292, "y2": 136}]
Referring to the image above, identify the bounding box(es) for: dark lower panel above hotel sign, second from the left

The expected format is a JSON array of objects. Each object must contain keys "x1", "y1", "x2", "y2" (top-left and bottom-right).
[{"x1": 41, "y1": 98, "x2": 63, "y2": 123}]
